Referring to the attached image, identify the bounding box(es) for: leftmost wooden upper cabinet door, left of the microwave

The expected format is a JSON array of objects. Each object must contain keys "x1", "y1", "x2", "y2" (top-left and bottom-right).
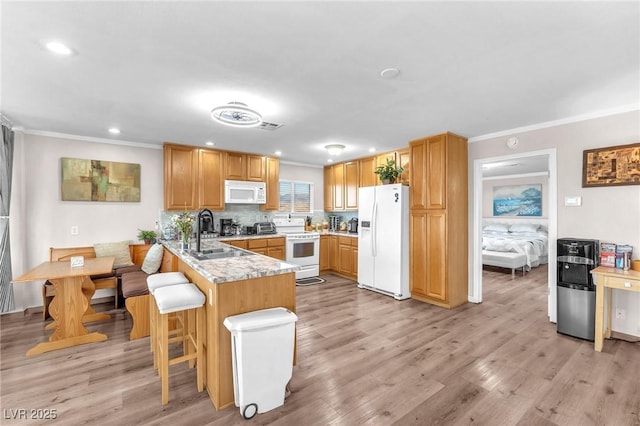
[{"x1": 163, "y1": 144, "x2": 198, "y2": 210}]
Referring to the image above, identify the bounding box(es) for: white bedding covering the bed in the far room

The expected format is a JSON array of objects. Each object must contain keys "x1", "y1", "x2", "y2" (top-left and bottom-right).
[{"x1": 482, "y1": 231, "x2": 549, "y2": 268}]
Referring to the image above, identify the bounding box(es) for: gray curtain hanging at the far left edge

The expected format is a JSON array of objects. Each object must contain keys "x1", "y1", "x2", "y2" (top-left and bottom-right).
[{"x1": 0, "y1": 123, "x2": 15, "y2": 312}]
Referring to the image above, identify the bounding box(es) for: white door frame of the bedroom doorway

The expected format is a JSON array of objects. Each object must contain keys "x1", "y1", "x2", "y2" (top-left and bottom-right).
[{"x1": 469, "y1": 149, "x2": 558, "y2": 322}]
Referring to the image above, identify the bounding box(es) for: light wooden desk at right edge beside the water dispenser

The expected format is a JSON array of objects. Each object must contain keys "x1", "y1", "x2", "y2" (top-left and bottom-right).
[{"x1": 591, "y1": 266, "x2": 640, "y2": 352}]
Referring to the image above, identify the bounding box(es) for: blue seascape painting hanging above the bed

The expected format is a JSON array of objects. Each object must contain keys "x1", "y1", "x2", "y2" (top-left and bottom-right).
[{"x1": 493, "y1": 184, "x2": 542, "y2": 216}]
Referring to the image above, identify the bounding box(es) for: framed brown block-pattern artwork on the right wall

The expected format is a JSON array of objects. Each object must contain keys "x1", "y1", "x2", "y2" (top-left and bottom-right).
[{"x1": 582, "y1": 143, "x2": 640, "y2": 188}]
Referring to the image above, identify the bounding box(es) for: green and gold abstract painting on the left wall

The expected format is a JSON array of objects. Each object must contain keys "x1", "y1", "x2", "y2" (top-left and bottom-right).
[{"x1": 61, "y1": 158, "x2": 140, "y2": 202}]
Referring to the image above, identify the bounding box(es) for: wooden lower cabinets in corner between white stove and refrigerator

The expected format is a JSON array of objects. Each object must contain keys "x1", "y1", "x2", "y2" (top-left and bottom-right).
[{"x1": 320, "y1": 235, "x2": 358, "y2": 280}]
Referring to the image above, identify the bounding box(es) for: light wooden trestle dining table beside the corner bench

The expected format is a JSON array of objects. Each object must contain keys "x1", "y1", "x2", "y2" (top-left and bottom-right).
[{"x1": 13, "y1": 257, "x2": 115, "y2": 356}]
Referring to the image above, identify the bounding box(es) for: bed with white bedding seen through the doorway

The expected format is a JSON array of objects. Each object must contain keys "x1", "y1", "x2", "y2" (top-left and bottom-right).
[{"x1": 482, "y1": 219, "x2": 549, "y2": 274}]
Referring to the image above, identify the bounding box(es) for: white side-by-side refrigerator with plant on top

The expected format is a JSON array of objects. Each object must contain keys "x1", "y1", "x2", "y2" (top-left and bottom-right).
[{"x1": 358, "y1": 184, "x2": 411, "y2": 300}]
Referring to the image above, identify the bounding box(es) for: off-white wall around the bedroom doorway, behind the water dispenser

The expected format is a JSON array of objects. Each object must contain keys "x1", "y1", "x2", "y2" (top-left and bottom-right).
[{"x1": 469, "y1": 110, "x2": 640, "y2": 336}]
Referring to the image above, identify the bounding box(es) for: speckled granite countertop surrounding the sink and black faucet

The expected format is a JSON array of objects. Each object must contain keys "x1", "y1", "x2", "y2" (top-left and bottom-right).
[{"x1": 163, "y1": 240, "x2": 300, "y2": 284}]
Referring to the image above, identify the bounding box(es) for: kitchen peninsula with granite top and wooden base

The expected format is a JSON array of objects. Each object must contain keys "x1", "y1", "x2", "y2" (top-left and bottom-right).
[{"x1": 163, "y1": 240, "x2": 299, "y2": 410}]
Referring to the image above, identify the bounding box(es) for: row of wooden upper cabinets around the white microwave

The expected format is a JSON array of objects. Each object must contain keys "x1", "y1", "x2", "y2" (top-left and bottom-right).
[{"x1": 164, "y1": 143, "x2": 280, "y2": 210}]
